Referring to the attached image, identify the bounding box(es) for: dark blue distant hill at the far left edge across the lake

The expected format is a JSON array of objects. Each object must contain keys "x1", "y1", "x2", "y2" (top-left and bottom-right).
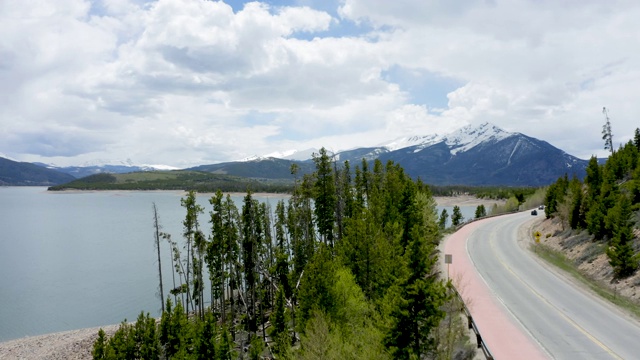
[{"x1": 0, "y1": 157, "x2": 74, "y2": 186}]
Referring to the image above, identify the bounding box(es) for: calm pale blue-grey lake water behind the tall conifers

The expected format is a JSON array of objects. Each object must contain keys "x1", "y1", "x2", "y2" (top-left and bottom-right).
[{"x1": 0, "y1": 187, "x2": 475, "y2": 341}]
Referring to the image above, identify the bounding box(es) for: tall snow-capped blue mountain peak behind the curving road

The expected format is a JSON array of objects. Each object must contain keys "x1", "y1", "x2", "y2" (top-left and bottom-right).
[{"x1": 379, "y1": 123, "x2": 588, "y2": 186}]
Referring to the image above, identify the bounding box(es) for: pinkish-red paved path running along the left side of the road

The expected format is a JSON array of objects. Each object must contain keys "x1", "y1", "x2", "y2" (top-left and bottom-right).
[{"x1": 442, "y1": 219, "x2": 548, "y2": 360}]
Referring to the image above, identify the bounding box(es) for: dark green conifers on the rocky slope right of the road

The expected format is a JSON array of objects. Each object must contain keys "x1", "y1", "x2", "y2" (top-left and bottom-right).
[{"x1": 544, "y1": 128, "x2": 640, "y2": 279}]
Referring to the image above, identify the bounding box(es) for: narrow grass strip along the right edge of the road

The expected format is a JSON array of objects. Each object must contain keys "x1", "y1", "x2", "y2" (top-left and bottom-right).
[{"x1": 534, "y1": 244, "x2": 640, "y2": 318}]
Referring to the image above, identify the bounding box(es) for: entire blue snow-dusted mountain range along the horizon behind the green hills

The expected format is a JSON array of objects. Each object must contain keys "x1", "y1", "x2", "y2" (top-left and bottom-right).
[{"x1": 0, "y1": 123, "x2": 588, "y2": 186}]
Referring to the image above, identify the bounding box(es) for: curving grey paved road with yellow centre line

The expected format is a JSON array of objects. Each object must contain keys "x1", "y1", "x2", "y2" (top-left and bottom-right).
[{"x1": 458, "y1": 212, "x2": 640, "y2": 359}]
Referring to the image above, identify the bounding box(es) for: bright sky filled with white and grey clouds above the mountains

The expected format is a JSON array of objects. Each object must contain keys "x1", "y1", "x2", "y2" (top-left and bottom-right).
[{"x1": 0, "y1": 0, "x2": 640, "y2": 168}]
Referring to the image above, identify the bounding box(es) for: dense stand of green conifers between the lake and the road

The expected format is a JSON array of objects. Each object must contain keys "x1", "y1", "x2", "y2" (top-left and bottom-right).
[{"x1": 93, "y1": 149, "x2": 472, "y2": 359}]
